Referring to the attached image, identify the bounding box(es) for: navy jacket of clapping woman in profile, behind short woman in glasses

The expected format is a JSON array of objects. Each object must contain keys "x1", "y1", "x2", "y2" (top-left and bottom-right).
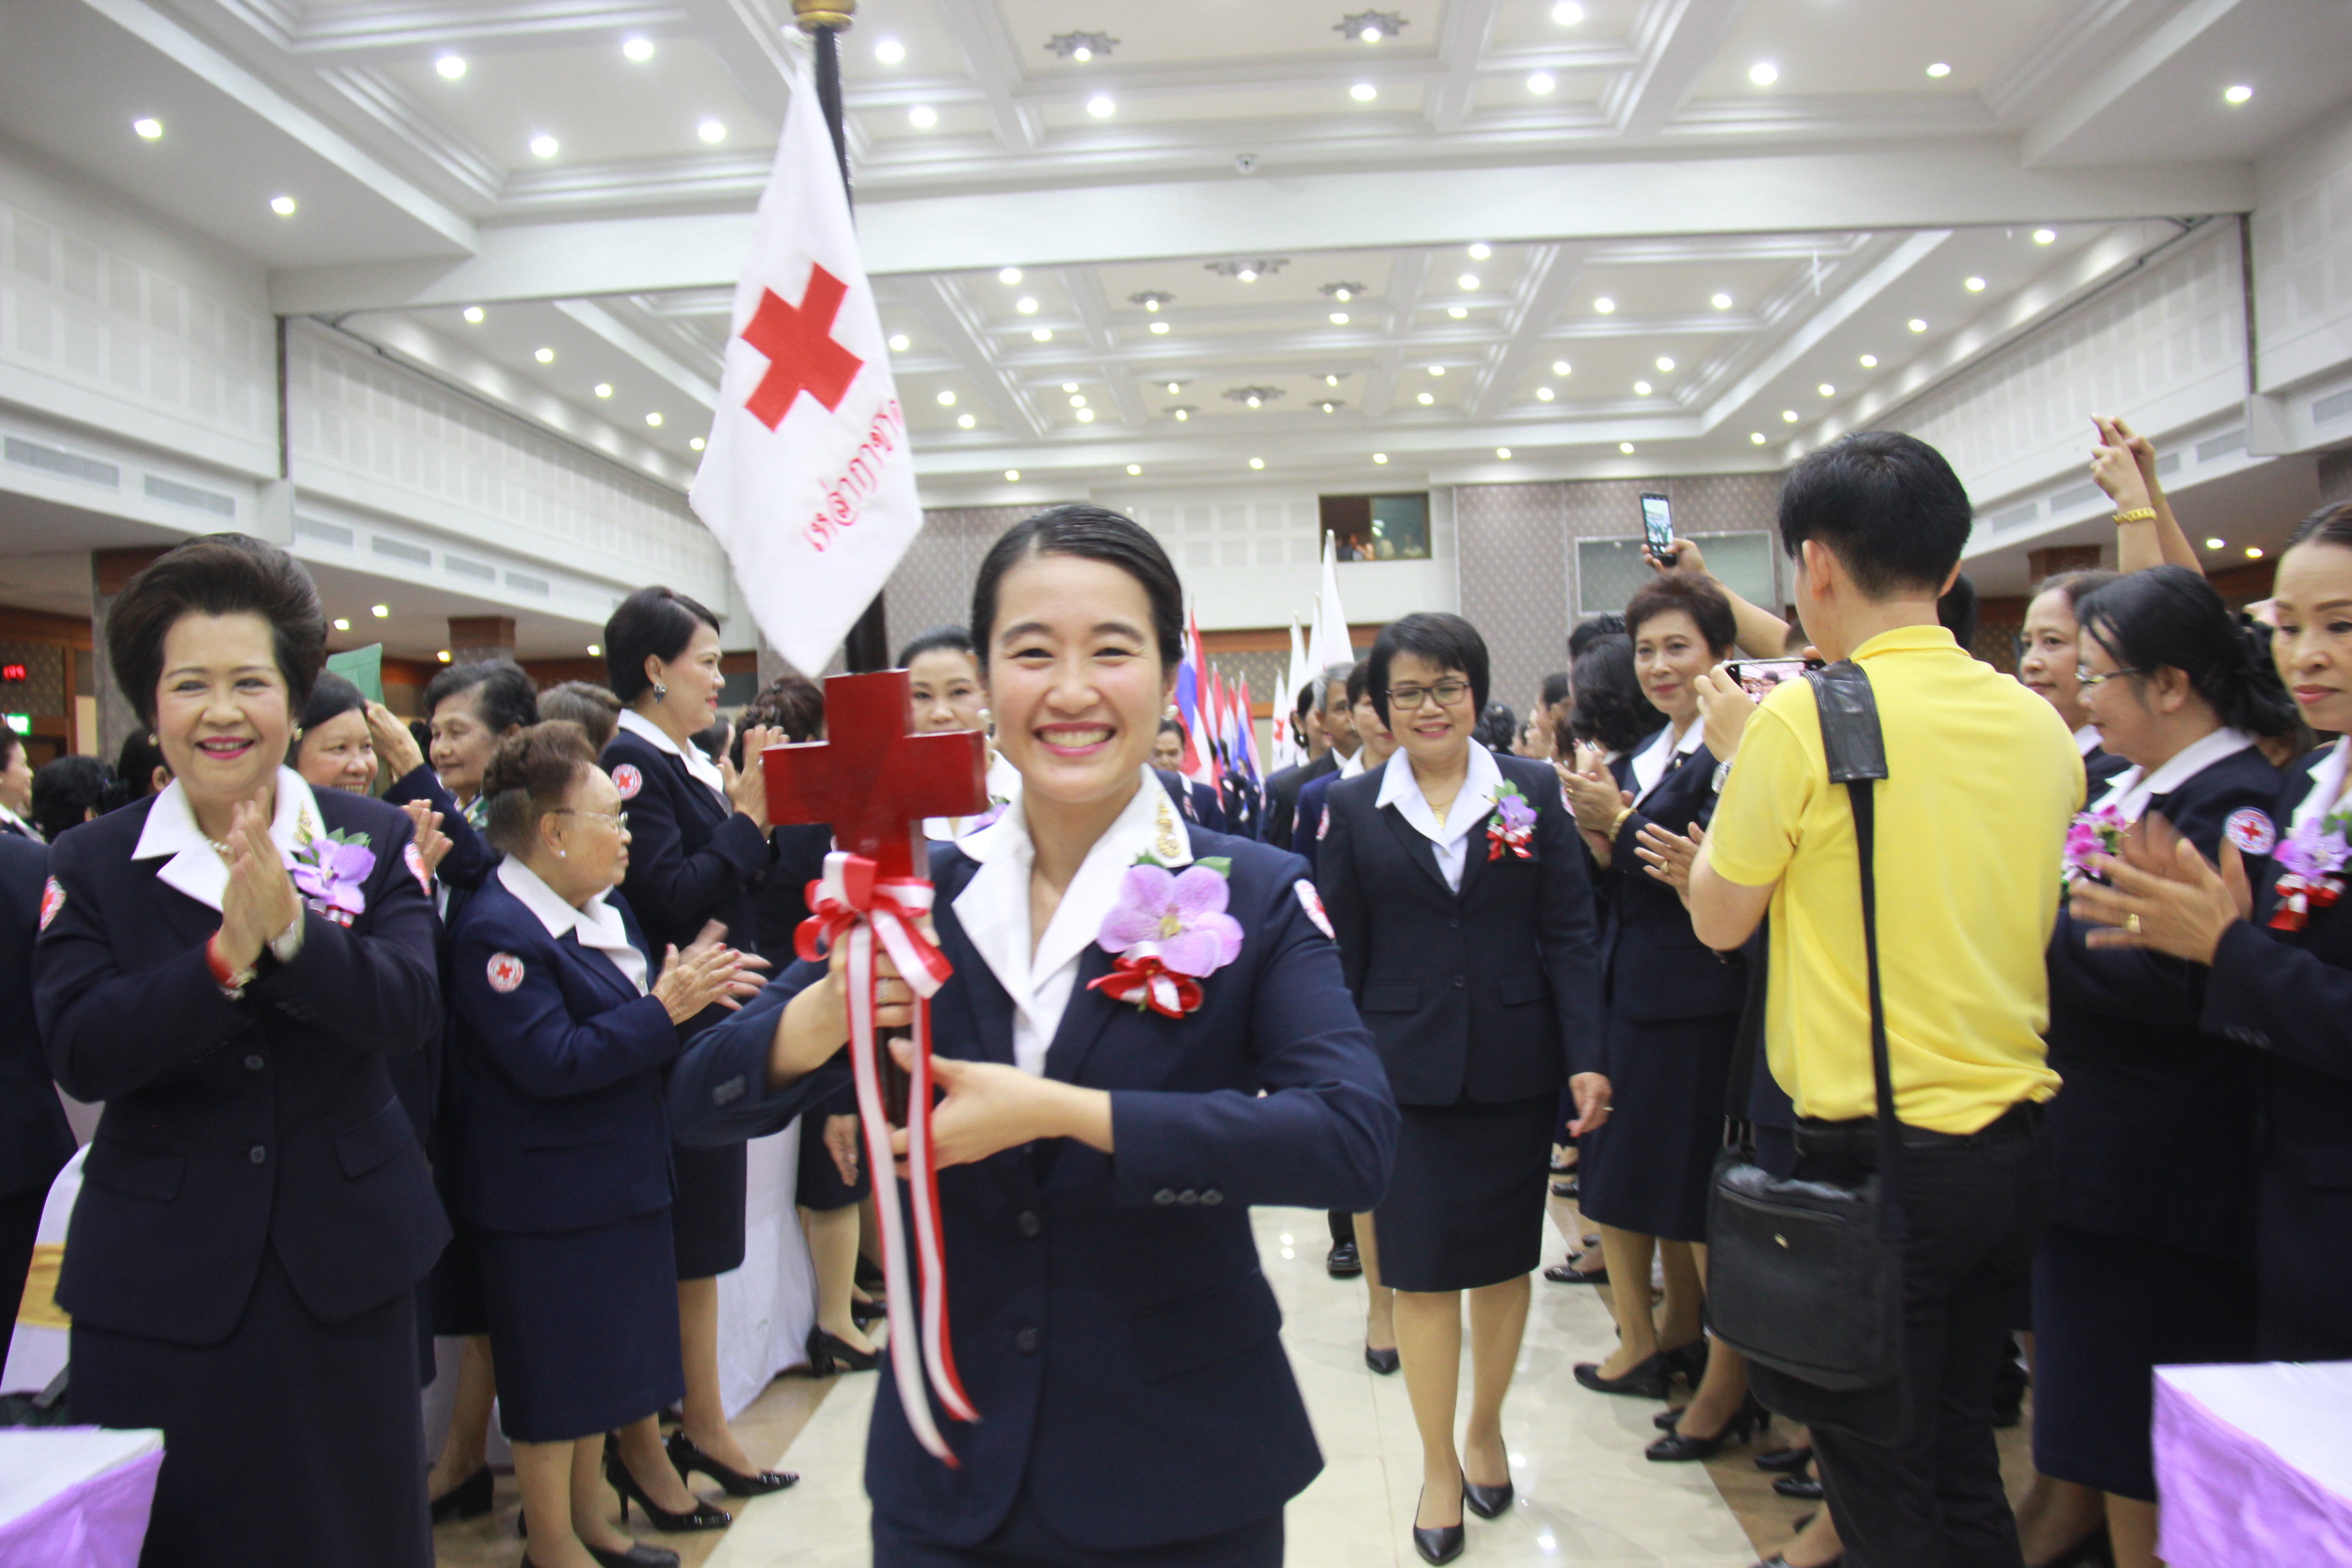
[{"x1": 600, "y1": 729, "x2": 783, "y2": 957}]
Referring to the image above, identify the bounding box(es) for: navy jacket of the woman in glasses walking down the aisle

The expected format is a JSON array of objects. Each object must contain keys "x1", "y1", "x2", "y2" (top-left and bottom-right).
[{"x1": 1317, "y1": 757, "x2": 1599, "y2": 1105}]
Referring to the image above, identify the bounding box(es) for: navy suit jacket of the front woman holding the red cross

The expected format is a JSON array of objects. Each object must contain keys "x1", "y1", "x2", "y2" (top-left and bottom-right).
[{"x1": 670, "y1": 828, "x2": 1397, "y2": 1552}]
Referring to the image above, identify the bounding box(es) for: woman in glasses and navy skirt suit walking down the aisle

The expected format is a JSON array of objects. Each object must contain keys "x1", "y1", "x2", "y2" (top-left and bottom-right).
[{"x1": 1315, "y1": 616, "x2": 1609, "y2": 1563}]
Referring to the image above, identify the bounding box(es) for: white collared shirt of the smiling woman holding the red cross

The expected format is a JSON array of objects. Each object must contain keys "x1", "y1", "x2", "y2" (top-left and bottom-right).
[{"x1": 955, "y1": 769, "x2": 1192, "y2": 1077}]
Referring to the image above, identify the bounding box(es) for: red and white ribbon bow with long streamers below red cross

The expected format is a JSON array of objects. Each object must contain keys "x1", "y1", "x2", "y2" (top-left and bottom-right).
[{"x1": 795, "y1": 851, "x2": 981, "y2": 1469}]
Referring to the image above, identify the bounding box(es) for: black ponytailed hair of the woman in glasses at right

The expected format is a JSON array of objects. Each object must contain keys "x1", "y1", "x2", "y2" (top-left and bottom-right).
[{"x1": 2074, "y1": 566, "x2": 2296, "y2": 738}]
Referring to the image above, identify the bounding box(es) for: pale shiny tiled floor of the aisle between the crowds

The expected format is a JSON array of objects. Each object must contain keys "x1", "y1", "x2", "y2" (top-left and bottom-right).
[{"x1": 440, "y1": 1208, "x2": 2023, "y2": 1568}]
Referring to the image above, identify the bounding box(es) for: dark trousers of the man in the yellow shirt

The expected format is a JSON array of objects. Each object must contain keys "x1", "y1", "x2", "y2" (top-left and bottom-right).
[{"x1": 1797, "y1": 1112, "x2": 2051, "y2": 1568}]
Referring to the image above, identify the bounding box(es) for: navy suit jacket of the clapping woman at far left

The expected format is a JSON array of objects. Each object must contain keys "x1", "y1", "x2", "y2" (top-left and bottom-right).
[{"x1": 33, "y1": 790, "x2": 449, "y2": 1345}]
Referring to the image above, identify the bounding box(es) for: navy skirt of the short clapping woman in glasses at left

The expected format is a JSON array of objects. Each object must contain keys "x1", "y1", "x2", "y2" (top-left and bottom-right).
[{"x1": 478, "y1": 1208, "x2": 687, "y2": 1443}]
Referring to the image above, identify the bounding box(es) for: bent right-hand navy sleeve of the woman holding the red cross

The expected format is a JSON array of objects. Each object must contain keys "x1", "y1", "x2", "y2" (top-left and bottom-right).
[{"x1": 1110, "y1": 855, "x2": 1399, "y2": 1211}]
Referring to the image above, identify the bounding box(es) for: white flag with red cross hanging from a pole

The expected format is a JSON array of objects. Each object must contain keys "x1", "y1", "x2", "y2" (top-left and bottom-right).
[{"x1": 691, "y1": 56, "x2": 922, "y2": 674}]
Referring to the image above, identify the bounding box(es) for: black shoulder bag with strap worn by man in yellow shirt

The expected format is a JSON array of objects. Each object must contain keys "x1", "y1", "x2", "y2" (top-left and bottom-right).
[{"x1": 1708, "y1": 663, "x2": 1905, "y2": 1443}]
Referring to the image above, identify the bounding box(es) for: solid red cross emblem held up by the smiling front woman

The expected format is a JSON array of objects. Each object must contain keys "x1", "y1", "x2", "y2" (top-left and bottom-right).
[{"x1": 762, "y1": 670, "x2": 988, "y2": 877}]
